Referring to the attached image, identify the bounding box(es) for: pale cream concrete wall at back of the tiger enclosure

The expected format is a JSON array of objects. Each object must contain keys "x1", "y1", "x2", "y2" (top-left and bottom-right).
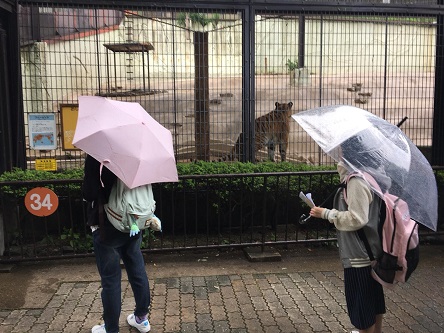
[{"x1": 21, "y1": 17, "x2": 435, "y2": 112}]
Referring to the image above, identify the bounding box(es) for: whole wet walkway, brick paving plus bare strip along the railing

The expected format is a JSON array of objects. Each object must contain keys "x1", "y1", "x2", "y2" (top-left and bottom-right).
[{"x1": 0, "y1": 245, "x2": 444, "y2": 333}]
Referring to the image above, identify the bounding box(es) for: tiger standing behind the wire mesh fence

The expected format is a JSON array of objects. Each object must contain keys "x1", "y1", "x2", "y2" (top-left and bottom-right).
[{"x1": 224, "y1": 102, "x2": 293, "y2": 162}]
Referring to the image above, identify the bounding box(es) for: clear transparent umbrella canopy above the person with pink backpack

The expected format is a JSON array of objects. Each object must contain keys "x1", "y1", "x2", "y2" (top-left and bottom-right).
[{"x1": 292, "y1": 105, "x2": 438, "y2": 231}]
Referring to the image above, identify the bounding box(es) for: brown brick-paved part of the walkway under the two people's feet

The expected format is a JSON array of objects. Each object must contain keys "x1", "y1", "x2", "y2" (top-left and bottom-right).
[{"x1": 0, "y1": 244, "x2": 444, "y2": 333}]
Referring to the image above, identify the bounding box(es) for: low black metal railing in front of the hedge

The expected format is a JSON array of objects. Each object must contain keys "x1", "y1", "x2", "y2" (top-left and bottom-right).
[{"x1": 0, "y1": 171, "x2": 436, "y2": 263}]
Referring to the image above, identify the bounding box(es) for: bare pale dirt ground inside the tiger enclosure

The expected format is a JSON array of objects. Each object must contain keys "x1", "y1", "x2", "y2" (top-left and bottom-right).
[{"x1": 99, "y1": 73, "x2": 434, "y2": 163}]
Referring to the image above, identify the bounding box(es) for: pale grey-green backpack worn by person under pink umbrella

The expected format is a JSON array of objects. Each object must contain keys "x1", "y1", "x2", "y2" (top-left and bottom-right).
[{"x1": 104, "y1": 178, "x2": 162, "y2": 236}]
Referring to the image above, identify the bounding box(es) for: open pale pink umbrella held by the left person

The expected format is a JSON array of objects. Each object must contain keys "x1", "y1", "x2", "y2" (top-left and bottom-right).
[{"x1": 72, "y1": 96, "x2": 178, "y2": 188}]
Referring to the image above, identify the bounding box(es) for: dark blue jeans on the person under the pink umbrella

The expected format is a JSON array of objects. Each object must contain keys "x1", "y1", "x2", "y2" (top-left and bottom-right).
[{"x1": 93, "y1": 230, "x2": 150, "y2": 333}]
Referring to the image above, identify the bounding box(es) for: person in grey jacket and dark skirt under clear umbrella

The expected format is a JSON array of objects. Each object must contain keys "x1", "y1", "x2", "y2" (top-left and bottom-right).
[{"x1": 310, "y1": 140, "x2": 386, "y2": 333}]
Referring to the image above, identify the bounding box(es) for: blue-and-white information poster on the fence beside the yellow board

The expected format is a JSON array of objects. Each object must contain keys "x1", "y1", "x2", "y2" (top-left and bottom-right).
[{"x1": 28, "y1": 113, "x2": 57, "y2": 150}]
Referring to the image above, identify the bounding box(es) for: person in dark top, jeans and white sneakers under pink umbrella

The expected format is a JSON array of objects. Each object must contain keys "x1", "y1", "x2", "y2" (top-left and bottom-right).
[{"x1": 82, "y1": 155, "x2": 151, "y2": 333}]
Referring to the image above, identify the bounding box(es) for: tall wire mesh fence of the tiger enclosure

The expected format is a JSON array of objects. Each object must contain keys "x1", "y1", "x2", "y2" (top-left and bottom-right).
[{"x1": 19, "y1": 1, "x2": 440, "y2": 169}]
